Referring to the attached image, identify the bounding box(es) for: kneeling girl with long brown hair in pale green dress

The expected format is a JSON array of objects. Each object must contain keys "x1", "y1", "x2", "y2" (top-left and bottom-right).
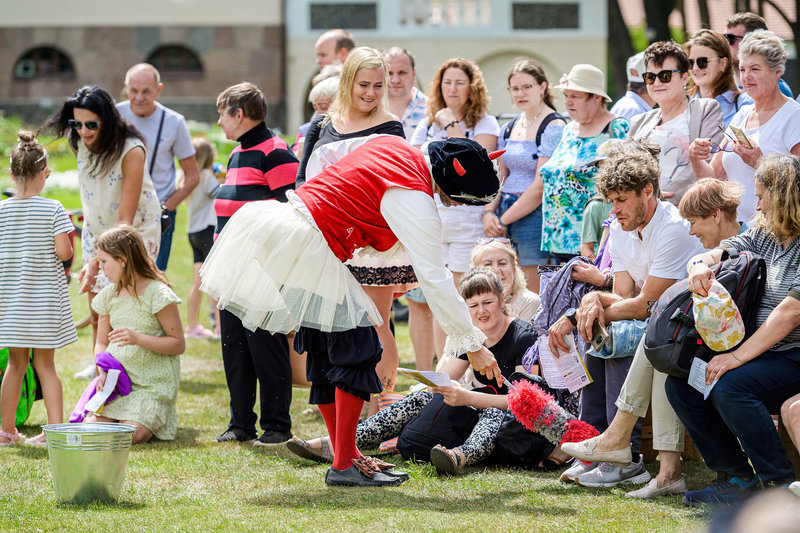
[{"x1": 86, "y1": 224, "x2": 184, "y2": 443}]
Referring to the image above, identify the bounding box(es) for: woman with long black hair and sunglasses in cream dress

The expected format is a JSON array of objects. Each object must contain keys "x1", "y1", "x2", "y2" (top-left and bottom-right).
[{"x1": 44, "y1": 85, "x2": 161, "y2": 340}]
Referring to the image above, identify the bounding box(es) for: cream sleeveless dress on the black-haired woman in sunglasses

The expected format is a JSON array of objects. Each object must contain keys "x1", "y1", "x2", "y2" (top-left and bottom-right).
[{"x1": 78, "y1": 137, "x2": 161, "y2": 292}]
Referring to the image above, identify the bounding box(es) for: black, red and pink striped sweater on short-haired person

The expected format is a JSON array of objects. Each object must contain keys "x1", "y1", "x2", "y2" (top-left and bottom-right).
[{"x1": 214, "y1": 122, "x2": 298, "y2": 236}]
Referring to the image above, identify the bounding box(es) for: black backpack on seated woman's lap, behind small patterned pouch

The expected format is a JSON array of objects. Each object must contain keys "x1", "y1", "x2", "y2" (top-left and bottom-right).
[{"x1": 644, "y1": 249, "x2": 767, "y2": 378}]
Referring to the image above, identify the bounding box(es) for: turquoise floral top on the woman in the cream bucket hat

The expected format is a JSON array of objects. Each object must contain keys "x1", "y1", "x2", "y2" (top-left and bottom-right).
[{"x1": 539, "y1": 117, "x2": 630, "y2": 255}]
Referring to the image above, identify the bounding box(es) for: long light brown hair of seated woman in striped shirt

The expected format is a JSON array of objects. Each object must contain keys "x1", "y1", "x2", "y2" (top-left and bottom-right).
[{"x1": 755, "y1": 154, "x2": 800, "y2": 241}]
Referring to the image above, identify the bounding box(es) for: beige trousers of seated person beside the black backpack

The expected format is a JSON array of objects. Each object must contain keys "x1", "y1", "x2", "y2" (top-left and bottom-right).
[{"x1": 616, "y1": 336, "x2": 685, "y2": 452}]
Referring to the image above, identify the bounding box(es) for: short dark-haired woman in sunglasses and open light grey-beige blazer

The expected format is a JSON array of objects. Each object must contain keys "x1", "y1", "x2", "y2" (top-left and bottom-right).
[{"x1": 629, "y1": 41, "x2": 722, "y2": 206}]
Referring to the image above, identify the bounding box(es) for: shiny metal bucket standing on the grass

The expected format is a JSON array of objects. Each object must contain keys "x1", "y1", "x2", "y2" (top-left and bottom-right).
[{"x1": 42, "y1": 422, "x2": 136, "y2": 503}]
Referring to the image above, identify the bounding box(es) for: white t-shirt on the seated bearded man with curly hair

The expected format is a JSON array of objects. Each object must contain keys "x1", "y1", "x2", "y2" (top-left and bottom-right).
[{"x1": 609, "y1": 202, "x2": 703, "y2": 289}]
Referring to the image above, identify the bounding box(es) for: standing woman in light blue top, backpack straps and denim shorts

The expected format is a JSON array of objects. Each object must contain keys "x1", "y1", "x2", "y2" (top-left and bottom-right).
[{"x1": 473, "y1": 59, "x2": 565, "y2": 291}]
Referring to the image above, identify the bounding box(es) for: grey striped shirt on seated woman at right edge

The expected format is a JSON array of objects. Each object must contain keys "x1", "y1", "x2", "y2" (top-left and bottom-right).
[{"x1": 719, "y1": 228, "x2": 800, "y2": 350}]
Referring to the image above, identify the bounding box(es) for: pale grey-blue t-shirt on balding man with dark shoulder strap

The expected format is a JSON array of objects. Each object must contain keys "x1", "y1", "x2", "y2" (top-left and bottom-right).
[{"x1": 117, "y1": 101, "x2": 194, "y2": 203}]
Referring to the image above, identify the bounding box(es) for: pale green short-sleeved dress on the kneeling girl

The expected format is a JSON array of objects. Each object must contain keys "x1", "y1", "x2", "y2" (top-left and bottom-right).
[{"x1": 92, "y1": 280, "x2": 181, "y2": 440}]
